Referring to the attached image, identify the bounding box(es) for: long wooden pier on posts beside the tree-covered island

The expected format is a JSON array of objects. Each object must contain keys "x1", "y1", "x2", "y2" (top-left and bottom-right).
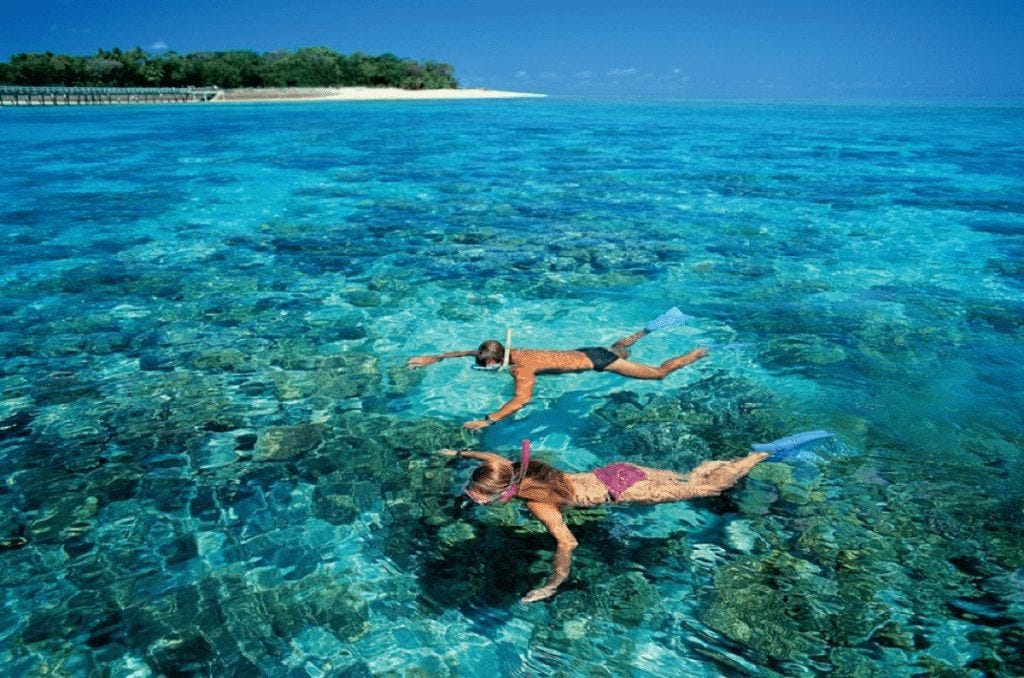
[{"x1": 0, "y1": 85, "x2": 221, "y2": 105}]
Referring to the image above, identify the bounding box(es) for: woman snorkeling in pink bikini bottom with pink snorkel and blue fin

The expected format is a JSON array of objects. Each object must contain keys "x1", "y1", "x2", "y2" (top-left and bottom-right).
[{"x1": 440, "y1": 431, "x2": 833, "y2": 602}]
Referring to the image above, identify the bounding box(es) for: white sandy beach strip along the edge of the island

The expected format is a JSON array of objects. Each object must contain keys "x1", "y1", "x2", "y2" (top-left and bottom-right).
[{"x1": 211, "y1": 87, "x2": 547, "y2": 103}]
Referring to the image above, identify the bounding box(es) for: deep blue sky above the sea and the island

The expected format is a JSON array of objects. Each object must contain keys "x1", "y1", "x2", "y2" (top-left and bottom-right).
[{"x1": 0, "y1": 0, "x2": 1024, "y2": 98}]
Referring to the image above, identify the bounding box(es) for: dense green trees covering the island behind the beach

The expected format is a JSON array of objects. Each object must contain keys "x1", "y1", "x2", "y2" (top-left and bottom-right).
[{"x1": 0, "y1": 47, "x2": 459, "y2": 89}]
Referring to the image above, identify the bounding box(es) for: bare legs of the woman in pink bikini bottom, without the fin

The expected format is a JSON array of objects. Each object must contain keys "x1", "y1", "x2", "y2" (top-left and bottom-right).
[{"x1": 618, "y1": 452, "x2": 769, "y2": 504}]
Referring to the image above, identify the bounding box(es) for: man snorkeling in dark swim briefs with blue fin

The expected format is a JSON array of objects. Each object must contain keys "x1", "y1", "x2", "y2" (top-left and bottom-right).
[{"x1": 406, "y1": 308, "x2": 708, "y2": 430}]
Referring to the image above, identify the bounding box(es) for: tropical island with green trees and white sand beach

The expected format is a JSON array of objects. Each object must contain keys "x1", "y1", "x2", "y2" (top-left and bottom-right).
[{"x1": 0, "y1": 47, "x2": 536, "y2": 101}]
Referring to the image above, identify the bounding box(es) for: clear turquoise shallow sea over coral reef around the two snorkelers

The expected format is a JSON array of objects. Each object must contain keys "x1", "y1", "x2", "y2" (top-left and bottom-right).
[{"x1": 0, "y1": 99, "x2": 1024, "y2": 676}]
